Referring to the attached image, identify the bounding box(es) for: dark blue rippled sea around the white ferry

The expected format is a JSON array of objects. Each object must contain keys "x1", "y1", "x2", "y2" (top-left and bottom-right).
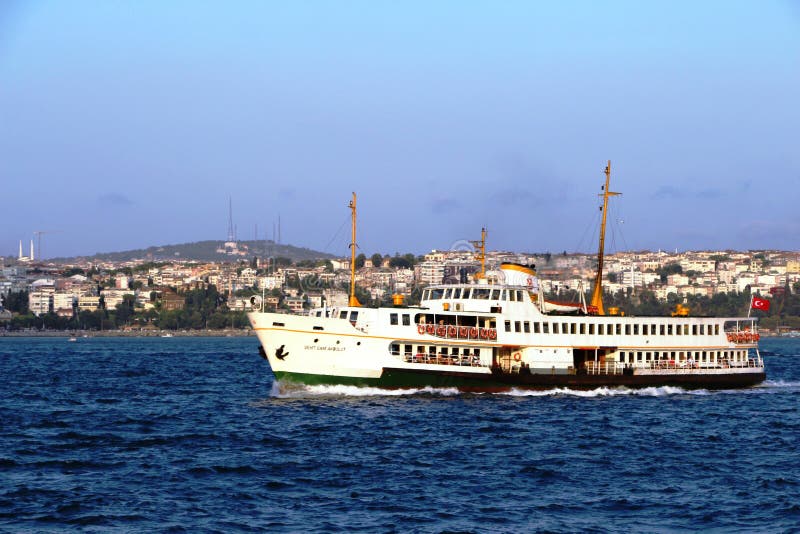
[{"x1": 0, "y1": 337, "x2": 800, "y2": 532}]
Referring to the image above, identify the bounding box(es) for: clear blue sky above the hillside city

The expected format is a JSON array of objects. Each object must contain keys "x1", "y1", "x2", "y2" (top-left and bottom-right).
[{"x1": 0, "y1": 0, "x2": 800, "y2": 258}]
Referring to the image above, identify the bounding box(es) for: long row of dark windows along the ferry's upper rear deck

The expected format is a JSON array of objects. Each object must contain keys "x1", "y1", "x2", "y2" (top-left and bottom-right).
[{"x1": 505, "y1": 321, "x2": 719, "y2": 336}]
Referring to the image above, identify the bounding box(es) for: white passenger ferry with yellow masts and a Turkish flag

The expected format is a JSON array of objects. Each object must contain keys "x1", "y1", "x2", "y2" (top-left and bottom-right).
[{"x1": 248, "y1": 162, "x2": 766, "y2": 392}]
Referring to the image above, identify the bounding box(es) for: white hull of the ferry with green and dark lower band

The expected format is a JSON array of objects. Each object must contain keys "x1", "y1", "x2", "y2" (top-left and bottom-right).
[{"x1": 249, "y1": 313, "x2": 765, "y2": 391}]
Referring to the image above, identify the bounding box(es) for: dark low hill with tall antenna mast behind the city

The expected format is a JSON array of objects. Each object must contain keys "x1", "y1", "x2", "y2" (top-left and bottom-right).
[{"x1": 50, "y1": 241, "x2": 335, "y2": 262}]
